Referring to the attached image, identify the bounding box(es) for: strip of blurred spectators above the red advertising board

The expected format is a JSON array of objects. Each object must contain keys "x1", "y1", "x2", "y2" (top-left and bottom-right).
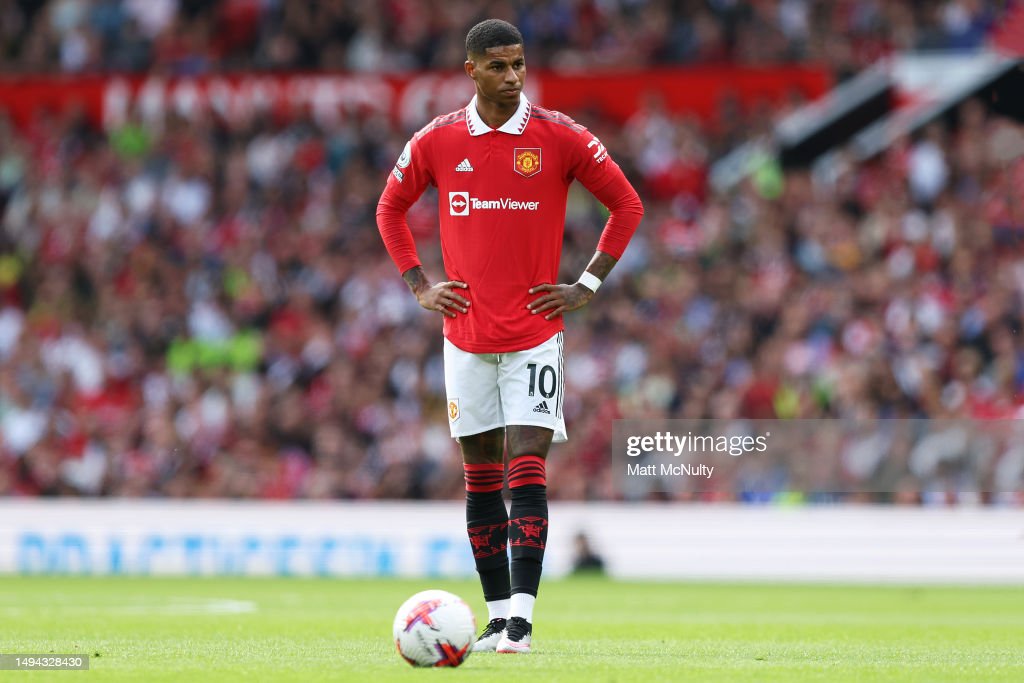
[{"x1": 0, "y1": 0, "x2": 1010, "y2": 76}]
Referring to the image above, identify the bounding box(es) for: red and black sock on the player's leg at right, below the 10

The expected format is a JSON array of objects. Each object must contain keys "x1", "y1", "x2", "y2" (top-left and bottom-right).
[{"x1": 509, "y1": 456, "x2": 548, "y2": 596}]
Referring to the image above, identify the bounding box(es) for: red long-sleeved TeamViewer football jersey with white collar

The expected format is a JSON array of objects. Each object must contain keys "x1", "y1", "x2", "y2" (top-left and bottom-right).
[{"x1": 378, "y1": 96, "x2": 642, "y2": 353}]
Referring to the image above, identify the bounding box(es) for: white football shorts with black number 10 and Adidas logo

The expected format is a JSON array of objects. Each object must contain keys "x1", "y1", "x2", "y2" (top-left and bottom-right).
[{"x1": 444, "y1": 332, "x2": 567, "y2": 442}]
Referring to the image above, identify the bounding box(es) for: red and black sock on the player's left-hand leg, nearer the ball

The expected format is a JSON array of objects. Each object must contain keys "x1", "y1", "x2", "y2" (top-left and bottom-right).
[{"x1": 463, "y1": 463, "x2": 512, "y2": 602}]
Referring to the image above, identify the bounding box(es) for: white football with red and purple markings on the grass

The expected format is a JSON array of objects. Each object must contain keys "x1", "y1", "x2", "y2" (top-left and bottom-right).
[{"x1": 393, "y1": 590, "x2": 476, "y2": 667}]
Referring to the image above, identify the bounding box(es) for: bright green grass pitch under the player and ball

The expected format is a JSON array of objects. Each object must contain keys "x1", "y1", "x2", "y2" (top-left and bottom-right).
[{"x1": 0, "y1": 577, "x2": 1024, "y2": 683}]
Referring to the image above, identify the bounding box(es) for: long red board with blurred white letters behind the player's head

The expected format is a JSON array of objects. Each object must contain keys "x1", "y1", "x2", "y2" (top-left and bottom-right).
[{"x1": 0, "y1": 67, "x2": 831, "y2": 129}]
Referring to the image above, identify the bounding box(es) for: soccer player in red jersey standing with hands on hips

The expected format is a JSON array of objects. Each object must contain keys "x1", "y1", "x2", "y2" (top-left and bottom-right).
[{"x1": 377, "y1": 19, "x2": 643, "y2": 652}]
